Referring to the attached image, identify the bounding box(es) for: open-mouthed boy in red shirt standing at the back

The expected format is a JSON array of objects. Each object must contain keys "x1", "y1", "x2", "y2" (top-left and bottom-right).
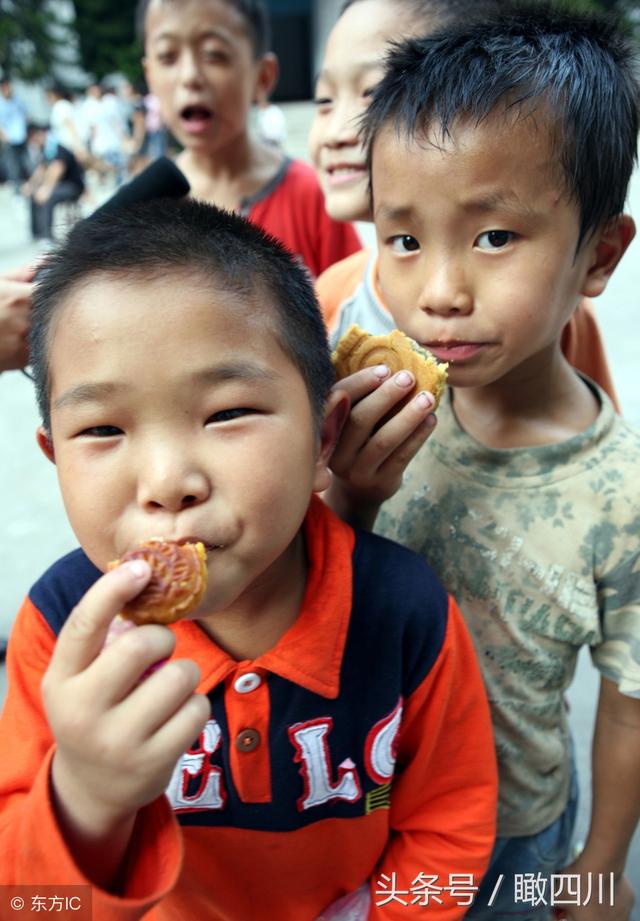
[{"x1": 137, "y1": 0, "x2": 362, "y2": 276}]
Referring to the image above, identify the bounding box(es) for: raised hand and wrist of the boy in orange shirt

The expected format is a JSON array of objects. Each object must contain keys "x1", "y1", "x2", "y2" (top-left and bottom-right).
[{"x1": 42, "y1": 559, "x2": 210, "y2": 887}]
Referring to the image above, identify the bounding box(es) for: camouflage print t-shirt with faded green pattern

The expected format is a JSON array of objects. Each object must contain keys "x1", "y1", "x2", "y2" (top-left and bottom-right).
[{"x1": 376, "y1": 385, "x2": 640, "y2": 836}]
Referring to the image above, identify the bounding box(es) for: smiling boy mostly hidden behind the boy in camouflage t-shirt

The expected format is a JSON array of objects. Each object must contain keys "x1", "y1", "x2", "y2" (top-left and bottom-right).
[{"x1": 309, "y1": 0, "x2": 619, "y2": 409}]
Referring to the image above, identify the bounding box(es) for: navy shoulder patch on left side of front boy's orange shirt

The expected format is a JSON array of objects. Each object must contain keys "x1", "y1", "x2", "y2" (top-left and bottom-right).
[{"x1": 29, "y1": 548, "x2": 101, "y2": 636}]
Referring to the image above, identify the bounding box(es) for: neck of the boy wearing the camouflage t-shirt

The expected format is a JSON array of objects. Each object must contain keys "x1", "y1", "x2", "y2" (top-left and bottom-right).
[{"x1": 452, "y1": 355, "x2": 599, "y2": 449}]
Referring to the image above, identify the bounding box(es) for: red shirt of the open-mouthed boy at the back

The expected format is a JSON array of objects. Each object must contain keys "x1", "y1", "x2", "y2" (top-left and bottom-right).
[{"x1": 249, "y1": 160, "x2": 362, "y2": 277}]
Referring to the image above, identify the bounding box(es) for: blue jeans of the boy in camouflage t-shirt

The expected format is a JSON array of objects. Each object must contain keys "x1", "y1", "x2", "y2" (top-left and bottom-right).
[{"x1": 465, "y1": 764, "x2": 578, "y2": 921}]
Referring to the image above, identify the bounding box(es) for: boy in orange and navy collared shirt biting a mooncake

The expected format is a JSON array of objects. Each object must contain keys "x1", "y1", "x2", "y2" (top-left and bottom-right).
[{"x1": 0, "y1": 201, "x2": 496, "y2": 921}]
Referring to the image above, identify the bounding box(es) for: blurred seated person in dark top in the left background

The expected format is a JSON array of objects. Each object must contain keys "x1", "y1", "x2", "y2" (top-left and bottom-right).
[{"x1": 22, "y1": 125, "x2": 84, "y2": 240}]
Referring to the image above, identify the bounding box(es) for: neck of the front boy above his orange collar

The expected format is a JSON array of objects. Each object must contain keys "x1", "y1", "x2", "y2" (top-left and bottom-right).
[{"x1": 198, "y1": 532, "x2": 308, "y2": 662}]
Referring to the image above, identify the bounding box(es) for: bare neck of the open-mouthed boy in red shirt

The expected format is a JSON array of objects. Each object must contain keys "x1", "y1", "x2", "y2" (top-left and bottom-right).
[{"x1": 177, "y1": 134, "x2": 282, "y2": 211}]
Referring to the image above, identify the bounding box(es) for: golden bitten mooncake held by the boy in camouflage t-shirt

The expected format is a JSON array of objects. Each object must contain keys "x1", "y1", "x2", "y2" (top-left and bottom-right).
[{"x1": 332, "y1": 323, "x2": 449, "y2": 413}]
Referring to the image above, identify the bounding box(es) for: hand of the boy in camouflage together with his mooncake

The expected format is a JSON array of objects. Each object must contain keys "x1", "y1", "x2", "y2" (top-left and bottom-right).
[{"x1": 326, "y1": 326, "x2": 447, "y2": 527}]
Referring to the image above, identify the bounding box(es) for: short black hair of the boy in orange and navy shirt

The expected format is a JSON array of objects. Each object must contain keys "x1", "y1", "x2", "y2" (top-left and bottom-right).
[{"x1": 30, "y1": 199, "x2": 334, "y2": 432}]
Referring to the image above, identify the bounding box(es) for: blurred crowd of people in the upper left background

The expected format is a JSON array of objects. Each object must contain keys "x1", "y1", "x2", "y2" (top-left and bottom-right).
[{"x1": 0, "y1": 79, "x2": 169, "y2": 241}]
